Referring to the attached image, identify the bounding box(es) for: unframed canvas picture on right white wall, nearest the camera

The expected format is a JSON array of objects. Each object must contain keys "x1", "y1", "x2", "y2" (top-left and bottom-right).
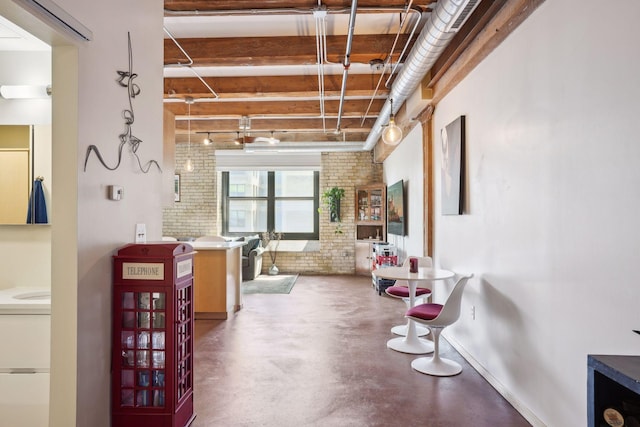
[{"x1": 441, "y1": 116, "x2": 465, "y2": 215}]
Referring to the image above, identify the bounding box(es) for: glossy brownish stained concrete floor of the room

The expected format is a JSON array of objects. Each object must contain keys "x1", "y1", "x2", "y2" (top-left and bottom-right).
[{"x1": 192, "y1": 276, "x2": 530, "y2": 427}]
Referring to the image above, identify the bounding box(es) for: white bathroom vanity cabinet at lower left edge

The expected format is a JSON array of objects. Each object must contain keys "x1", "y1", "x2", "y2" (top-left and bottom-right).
[{"x1": 0, "y1": 290, "x2": 51, "y2": 427}]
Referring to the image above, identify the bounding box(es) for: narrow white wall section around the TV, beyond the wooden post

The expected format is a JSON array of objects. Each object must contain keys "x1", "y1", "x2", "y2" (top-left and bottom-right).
[{"x1": 383, "y1": 125, "x2": 425, "y2": 263}]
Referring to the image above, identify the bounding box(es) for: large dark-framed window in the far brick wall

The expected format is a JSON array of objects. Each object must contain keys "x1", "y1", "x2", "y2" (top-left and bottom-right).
[{"x1": 222, "y1": 170, "x2": 320, "y2": 240}]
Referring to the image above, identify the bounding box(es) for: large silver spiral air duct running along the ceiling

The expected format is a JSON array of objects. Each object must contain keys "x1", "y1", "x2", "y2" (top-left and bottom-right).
[{"x1": 362, "y1": 0, "x2": 469, "y2": 151}]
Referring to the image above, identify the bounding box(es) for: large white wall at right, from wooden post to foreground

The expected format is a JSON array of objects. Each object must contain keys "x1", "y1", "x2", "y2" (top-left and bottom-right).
[{"x1": 434, "y1": 0, "x2": 640, "y2": 426}]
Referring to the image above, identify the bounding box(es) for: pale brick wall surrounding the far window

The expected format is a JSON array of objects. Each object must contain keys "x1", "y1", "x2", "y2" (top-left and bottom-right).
[{"x1": 163, "y1": 144, "x2": 382, "y2": 274}]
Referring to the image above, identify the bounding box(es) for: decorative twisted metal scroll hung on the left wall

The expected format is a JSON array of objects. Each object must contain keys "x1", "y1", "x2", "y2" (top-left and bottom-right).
[{"x1": 84, "y1": 33, "x2": 162, "y2": 173}]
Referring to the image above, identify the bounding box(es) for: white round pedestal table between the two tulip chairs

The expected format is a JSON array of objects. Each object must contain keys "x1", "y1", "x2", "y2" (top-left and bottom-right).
[{"x1": 375, "y1": 265, "x2": 455, "y2": 354}]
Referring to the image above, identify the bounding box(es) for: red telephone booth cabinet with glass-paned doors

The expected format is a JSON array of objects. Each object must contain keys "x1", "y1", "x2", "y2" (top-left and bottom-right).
[{"x1": 111, "y1": 243, "x2": 195, "y2": 427}]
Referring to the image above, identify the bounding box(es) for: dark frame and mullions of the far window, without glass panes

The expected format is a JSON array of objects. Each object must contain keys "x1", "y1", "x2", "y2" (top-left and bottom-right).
[{"x1": 221, "y1": 170, "x2": 320, "y2": 240}]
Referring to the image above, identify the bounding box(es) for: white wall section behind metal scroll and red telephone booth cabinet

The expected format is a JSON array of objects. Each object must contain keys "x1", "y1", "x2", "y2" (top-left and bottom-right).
[{"x1": 54, "y1": 0, "x2": 165, "y2": 427}]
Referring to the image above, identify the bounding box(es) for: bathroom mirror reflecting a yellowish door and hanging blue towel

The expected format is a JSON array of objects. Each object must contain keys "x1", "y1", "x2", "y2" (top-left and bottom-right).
[{"x1": 0, "y1": 125, "x2": 51, "y2": 224}]
